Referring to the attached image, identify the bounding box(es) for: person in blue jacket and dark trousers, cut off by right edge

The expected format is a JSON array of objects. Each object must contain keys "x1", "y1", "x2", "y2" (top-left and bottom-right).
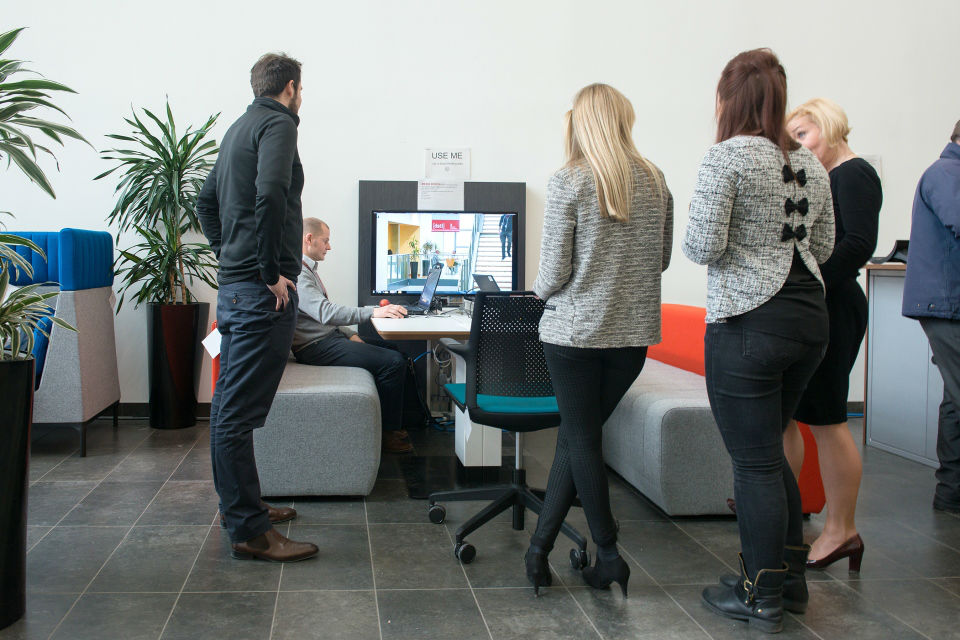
[{"x1": 903, "y1": 122, "x2": 960, "y2": 513}]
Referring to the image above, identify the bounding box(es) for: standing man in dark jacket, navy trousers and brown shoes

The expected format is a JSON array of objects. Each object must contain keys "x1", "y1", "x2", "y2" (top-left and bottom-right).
[{"x1": 197, "y1": 53, "x2": 317, "y2": 562}]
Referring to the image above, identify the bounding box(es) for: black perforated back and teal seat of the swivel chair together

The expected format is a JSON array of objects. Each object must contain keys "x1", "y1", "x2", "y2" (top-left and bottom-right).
[{"x1": 465, "y1": 292, "x2": 560, "y2": 431}]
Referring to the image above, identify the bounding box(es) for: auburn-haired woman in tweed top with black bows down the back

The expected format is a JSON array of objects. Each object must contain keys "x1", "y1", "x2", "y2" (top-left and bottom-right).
[{"x1": 683, "y1": 49, "x2": 834, "y2": 632}]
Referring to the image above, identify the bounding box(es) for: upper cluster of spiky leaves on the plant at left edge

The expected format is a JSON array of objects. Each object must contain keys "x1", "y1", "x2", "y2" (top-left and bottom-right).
[{"x1": 0, "y1": 27, "x2": 90, "y2": 200}]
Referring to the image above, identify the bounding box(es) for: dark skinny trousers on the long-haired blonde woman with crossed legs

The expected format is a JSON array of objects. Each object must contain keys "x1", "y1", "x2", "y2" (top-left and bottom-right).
[{"x1": 533, "y1": 343, "x2": 647, "y2": 551}]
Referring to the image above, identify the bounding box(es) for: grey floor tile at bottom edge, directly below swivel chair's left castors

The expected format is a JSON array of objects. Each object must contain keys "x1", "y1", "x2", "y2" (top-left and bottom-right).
[{"x1": 377, "y1": 584, "x2": 490, "y2": 640}]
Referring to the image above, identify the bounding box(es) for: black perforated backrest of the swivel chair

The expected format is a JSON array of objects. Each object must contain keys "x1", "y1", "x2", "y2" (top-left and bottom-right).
[{"x1": 466, "y1": 292, "x2": 554, "y2": 405}]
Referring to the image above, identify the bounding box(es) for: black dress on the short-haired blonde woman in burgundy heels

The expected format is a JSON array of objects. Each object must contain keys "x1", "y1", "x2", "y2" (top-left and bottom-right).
[{"x1": 794, "y1": 158, "x2": 883, "y2": 425}]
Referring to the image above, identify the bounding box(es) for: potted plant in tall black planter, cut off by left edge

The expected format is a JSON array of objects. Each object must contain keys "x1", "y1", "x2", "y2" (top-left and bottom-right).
[{"x1": 0, "y1": 28, "x2": 86, "y2": 629}]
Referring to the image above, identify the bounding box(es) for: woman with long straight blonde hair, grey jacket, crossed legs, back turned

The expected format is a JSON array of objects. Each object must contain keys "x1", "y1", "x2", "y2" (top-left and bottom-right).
[{"x1": 525, "y1": 84, "x2": 673, "y2": 596}]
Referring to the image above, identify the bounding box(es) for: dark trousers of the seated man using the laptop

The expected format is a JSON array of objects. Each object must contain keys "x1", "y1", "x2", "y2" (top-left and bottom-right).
[{"x1": 293, "y1": 331, "x2": 407, "y2": 431}]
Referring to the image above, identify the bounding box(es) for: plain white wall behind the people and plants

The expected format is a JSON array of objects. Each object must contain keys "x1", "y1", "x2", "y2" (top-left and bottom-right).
[{"x1": 0, "y1": 0, "x2": 960, "y2": 402}]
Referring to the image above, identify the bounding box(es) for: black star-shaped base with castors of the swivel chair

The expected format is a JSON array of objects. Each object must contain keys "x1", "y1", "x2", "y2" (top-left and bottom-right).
[{"x1": 427, "y1": 469, "x2": 587, "y2": 559}]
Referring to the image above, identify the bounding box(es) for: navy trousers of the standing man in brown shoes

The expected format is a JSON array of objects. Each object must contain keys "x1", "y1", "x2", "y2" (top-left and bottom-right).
[{"x1": 210, "y1": 280, "x2": 298, "y2": 542}]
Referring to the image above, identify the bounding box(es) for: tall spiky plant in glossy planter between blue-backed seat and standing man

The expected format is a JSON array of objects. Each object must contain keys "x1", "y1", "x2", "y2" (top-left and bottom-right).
[{"x1": 95, "y1": 101, "x2": 219, "y2": 429}]
